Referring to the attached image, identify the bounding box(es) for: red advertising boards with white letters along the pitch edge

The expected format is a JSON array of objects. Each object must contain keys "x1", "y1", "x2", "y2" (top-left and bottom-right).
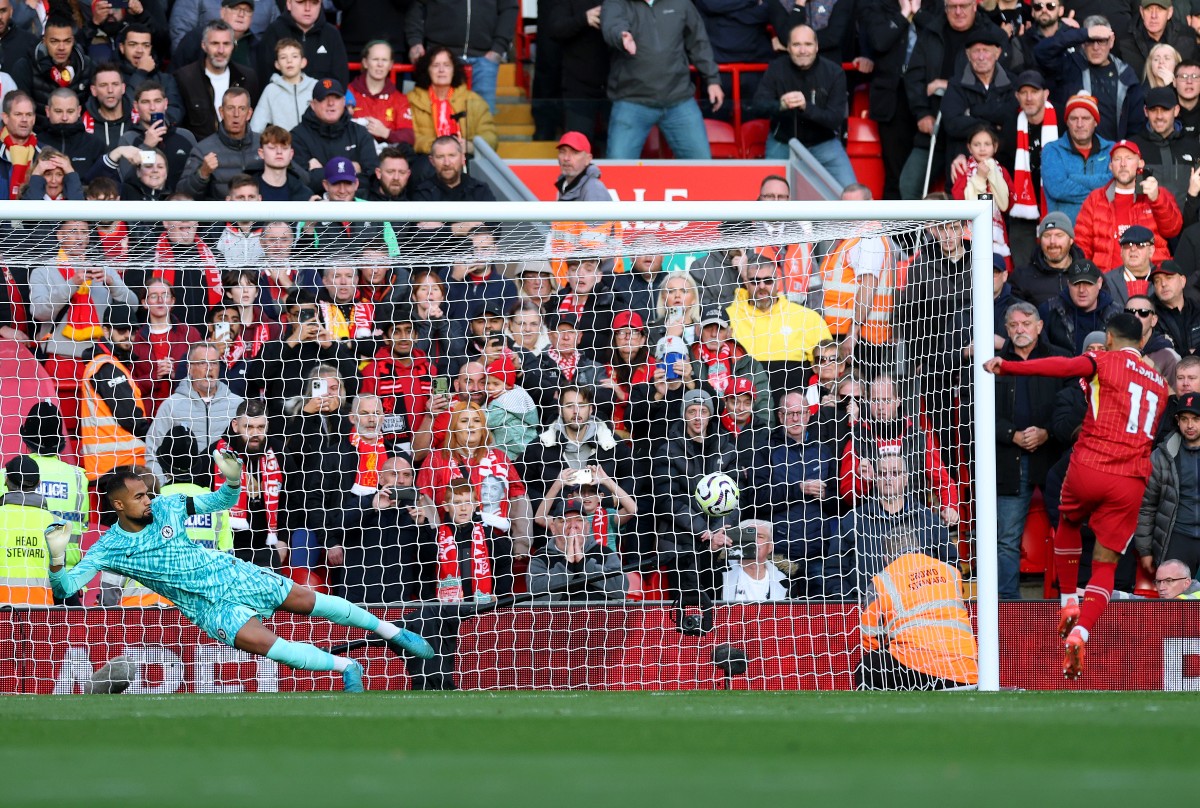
[{"x1": 9, "y1": 601, "x2": 1200, "y2": 694}]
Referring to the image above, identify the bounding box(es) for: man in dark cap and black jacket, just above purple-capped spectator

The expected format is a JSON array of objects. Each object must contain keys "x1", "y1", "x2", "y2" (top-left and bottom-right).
[{"x1": 292, "y1": 77, "x2": 379, "y2": 193}]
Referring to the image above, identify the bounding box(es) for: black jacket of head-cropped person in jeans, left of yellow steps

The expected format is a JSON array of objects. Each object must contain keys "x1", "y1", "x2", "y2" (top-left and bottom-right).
[{"x1": 404, "y1": 0, "x2": 520, "y2": 56}]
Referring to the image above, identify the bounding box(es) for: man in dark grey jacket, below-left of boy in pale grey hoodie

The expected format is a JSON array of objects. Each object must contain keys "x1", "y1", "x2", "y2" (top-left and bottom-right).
[{"x1": 180, "y1": 86, "x2": 263, "y2": 199}]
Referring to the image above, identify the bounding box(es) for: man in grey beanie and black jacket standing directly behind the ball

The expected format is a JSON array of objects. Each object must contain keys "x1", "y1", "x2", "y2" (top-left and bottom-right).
[{"x1": 652, "y1": 390, "x2": 738, "y2": 604}]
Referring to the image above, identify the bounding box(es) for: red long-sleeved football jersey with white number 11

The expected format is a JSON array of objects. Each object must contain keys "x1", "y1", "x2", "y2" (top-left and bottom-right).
[{"x1": 1001, "y1": 348, "x2": 1170, "y2": 479}]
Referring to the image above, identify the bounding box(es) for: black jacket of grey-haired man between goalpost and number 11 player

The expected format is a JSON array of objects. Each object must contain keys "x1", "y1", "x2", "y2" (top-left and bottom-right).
[{"x1": 996, "y1": 341, "x2": 1074, "y2": 497}]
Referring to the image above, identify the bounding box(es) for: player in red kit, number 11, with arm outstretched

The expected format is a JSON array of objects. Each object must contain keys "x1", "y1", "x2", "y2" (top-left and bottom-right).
[{"x1": 984, "y1": 313, "x2": 1170, "y2": 678}]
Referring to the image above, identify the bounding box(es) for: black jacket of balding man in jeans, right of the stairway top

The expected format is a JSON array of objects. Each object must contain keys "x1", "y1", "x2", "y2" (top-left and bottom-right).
[{"x1": 751, "y1": 55, "x2": 847, "y2": 145}]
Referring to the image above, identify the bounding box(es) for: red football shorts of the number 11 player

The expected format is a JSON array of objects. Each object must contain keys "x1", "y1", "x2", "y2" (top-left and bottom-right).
[{"x1": 1058, "y1": 462, "x2": 1146, "y2": 555}]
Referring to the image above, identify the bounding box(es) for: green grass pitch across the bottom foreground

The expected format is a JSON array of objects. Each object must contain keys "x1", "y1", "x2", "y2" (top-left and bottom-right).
[{"x1": 0, "y1": 692, "x2": 1200, "y2": 808}]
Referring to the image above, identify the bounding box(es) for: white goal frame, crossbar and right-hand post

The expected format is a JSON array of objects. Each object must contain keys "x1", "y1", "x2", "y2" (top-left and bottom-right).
[{"x1": 7, "y1": 200, "x2": 1000, "y2": 692}]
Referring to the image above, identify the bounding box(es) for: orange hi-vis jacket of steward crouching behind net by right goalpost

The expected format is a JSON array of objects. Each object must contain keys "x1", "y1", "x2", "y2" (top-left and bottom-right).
[{"x1": 862, "y1": 552, "x2": 979, "y2": 684}]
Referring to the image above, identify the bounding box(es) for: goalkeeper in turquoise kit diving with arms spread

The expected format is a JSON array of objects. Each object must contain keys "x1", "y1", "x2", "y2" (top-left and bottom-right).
[{"x1": 46, "y1": 449, "x2": 433, "y2": 693}]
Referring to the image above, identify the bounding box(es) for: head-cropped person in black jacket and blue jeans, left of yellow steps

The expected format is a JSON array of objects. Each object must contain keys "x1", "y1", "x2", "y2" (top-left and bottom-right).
[{"x1": 404, "y1": 0, "x2": 518, "y2": 115}]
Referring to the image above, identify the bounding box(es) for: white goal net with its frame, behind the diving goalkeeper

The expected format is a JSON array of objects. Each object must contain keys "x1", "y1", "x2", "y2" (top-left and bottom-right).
[{"x1": 0, "y1": 200, "x2": 996, "y2": 693}]
